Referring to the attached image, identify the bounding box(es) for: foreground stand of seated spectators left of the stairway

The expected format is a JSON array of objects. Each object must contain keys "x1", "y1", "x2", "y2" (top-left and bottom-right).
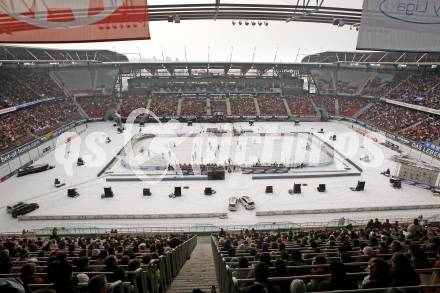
[{"x1": 0, "y1": 230, "x2": 197, "y2": 293}]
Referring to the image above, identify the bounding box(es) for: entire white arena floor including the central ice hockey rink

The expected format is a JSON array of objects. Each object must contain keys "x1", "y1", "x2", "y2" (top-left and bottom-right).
[{"x1": 0, "y1": 121, "x2": 440, "y2": 232}]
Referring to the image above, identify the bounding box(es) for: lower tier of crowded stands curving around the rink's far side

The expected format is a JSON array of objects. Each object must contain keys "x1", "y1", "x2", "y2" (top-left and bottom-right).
[{"x1": 0, "y1": 95, "x2": 439, "y2": 152}]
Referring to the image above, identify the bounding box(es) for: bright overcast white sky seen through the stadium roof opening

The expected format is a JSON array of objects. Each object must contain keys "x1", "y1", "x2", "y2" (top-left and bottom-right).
[{"x1": 15, "y1": 0, "x2": 363, "y2": 62}]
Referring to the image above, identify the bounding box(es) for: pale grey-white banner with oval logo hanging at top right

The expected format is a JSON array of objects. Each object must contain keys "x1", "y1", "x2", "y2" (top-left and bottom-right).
[{"x1": 357, "y1": 0, "x2": 440, "y2": 52}]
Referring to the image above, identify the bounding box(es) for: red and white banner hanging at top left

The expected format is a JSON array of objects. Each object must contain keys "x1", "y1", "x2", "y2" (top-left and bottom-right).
[{"x1": 0, "y1": 0, "x2": 150, "y2": 43}]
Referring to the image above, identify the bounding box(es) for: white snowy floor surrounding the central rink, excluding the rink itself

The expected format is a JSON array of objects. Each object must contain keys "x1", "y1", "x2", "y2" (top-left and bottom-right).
[{"x1": 0, "y1": 122, "x2": 440, "y2": 232}]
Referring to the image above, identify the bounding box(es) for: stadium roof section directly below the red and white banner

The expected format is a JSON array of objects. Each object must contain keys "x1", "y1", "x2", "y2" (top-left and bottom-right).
[{"x1": 0, "y1": 46, "x2": 128, "y2": 63}]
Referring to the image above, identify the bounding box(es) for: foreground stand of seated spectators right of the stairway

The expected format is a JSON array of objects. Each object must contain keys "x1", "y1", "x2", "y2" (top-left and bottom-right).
[{"x1": 212, "y1": 219, "x2": 439, "y2": 293}]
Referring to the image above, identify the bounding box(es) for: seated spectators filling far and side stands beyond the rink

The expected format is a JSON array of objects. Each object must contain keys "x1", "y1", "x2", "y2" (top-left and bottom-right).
[{"x1": 0, "y1": 69, "x2": 440, "y2": 152}]
